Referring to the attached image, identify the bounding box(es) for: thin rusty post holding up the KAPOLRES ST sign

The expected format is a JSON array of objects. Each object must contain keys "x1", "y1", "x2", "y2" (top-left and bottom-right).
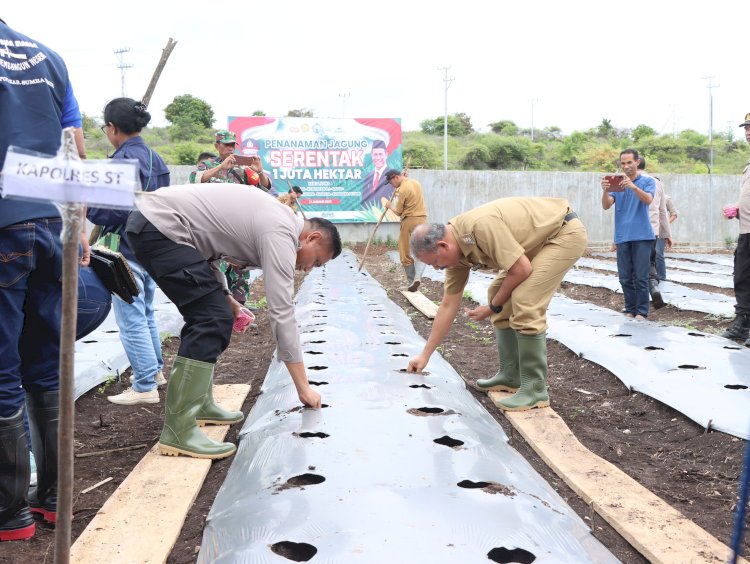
[{"x1": 55, "y1": 128, "x2": 83, "y2": 564}]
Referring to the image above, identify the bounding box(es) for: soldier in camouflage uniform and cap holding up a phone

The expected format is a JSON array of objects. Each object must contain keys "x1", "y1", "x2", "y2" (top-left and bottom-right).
[{"x1": 188, "y1": 129, "x2": 271, "y2": 304}]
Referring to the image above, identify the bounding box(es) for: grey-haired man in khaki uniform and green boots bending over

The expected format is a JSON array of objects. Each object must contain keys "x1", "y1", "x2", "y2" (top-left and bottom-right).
[{"x1": 408, "y1": 198, "x2": 586, "y2": 411}]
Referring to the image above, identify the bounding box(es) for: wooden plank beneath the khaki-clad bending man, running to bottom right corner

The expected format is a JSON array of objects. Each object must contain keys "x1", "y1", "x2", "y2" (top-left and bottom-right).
[{"x1": 489, "y1": 392, "x2": 747, "y2": 564}]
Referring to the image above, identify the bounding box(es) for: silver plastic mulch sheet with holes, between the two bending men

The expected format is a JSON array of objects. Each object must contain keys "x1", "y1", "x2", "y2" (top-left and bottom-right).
[{"x1": 199, "y1": 253, "x2": 616, "y2": 564}]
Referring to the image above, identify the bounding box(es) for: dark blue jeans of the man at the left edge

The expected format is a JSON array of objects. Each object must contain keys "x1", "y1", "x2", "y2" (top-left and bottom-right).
[{"x1": 0, "y1": 218, "x2": 62, "y2": 417}]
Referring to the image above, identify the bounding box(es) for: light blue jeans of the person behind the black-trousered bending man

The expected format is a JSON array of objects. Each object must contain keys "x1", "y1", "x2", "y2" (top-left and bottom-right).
[{"x1": 112, "y1": 261, "x2": 164, "y2": 392}]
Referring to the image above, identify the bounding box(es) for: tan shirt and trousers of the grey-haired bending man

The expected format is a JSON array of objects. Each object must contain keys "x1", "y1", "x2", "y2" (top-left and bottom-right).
[{"x1": 445, "y1": 198, "x2": 587, "y2": 335}]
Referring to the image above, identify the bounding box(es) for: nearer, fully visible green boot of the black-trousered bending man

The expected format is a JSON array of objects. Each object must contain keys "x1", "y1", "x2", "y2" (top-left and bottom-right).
[{"x1": 159, "y1": 356, "x2": 237, "y2": 458}]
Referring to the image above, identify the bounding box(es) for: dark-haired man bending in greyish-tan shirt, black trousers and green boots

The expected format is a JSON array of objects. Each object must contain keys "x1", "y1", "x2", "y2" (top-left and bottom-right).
[{"x1": 125, "y1": 183, "x2": 341, "y2": 458}]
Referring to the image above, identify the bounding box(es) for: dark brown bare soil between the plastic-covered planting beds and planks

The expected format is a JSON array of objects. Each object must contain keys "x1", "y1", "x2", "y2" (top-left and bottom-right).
[{"x1": 0, "y1": 246, "x2": 750, "y2": 563}]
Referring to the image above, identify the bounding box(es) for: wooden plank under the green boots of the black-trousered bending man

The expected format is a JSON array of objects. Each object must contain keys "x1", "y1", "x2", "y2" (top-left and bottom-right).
[{"x1": 70, "y1": 384, "x2": 250, "y2": 564}]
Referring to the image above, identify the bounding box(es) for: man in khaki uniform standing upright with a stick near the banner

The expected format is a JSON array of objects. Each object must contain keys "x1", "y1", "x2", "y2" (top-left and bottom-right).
[{"x1": 384, "y1": 169, "x2": 427, "y2": 292}]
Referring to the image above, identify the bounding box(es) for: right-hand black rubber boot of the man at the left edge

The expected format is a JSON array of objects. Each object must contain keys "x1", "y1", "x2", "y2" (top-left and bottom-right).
[{"x1": 26, "y1": 390, "x2": 60, "y2": 523}]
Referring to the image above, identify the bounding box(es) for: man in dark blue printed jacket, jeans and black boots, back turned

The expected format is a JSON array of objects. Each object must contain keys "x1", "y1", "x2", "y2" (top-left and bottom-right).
[{"x1": 0, "y1": 16, "x2": 82, "y2": 541}]
